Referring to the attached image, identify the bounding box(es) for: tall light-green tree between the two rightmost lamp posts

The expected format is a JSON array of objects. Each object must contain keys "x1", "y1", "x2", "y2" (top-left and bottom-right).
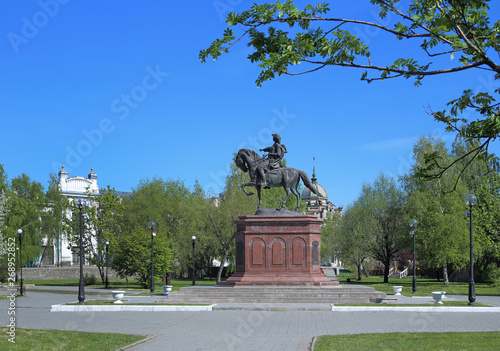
[{"x1": 401, "y1": 137, "x2": 469, "y2": 285}]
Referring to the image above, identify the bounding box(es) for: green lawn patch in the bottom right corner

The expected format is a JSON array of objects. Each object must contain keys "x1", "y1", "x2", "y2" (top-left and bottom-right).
[{"x1": 314, "y1": 332, "x2": 500, "y2": 351}]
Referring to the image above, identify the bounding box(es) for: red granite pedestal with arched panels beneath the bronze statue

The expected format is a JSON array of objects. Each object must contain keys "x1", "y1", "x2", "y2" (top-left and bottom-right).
[{"x1": 219, "y1": 215, "x2": 338, "y2": 286}]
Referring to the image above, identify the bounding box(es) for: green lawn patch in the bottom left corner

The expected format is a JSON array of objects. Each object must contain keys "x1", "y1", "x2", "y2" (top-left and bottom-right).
[{"x1": 0, "y1": 328, "x2": 145, "y2": 351}]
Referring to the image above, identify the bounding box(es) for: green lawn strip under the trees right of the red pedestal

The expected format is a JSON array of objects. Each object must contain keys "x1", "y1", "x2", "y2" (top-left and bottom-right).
[{"x1": 339, "y1": 276, "x2": 500, "y2": 296}]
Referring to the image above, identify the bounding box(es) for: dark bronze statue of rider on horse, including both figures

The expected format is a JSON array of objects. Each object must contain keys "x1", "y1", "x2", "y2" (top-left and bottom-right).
[{"x1": 234, "y1": 134, "x2": 319, "y2": 212}]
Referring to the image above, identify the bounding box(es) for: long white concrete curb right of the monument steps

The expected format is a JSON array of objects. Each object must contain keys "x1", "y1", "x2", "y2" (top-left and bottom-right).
[{"x1": 332, "y1": 305, "x2": 500, "y2": 313}]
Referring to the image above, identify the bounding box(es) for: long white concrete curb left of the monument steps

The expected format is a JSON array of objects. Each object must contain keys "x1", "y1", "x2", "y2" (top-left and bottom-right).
[{"x1": 50, "y1": 304, "x2": 215, "y2": 312}]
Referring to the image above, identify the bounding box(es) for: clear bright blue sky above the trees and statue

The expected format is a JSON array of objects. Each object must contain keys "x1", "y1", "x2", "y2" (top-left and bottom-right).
[{"x1": 0, "y1": 0, "x2": 500, "y2": 205}]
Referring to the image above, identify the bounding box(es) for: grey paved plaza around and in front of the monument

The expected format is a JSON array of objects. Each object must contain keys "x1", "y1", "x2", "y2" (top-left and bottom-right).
[{"x1": 0, "y1": 289, "x2": 500, "y2": 351}]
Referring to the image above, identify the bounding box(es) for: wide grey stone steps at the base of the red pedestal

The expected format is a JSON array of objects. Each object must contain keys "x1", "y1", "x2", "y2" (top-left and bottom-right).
[{"x1": 157, "y1": 286, "x2": 386, "y2": 304}]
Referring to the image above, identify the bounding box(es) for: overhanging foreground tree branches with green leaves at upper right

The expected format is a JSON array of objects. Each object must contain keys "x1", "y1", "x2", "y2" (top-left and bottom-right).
[{"x1": 199, "y1": 0, "x2": 500, "y2": 177}]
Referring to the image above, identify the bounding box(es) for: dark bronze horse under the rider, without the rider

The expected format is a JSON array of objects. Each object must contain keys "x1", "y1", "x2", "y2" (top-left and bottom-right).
[{"x1": 234, "y1": 149, "x2": 319, "y2": 212}]
